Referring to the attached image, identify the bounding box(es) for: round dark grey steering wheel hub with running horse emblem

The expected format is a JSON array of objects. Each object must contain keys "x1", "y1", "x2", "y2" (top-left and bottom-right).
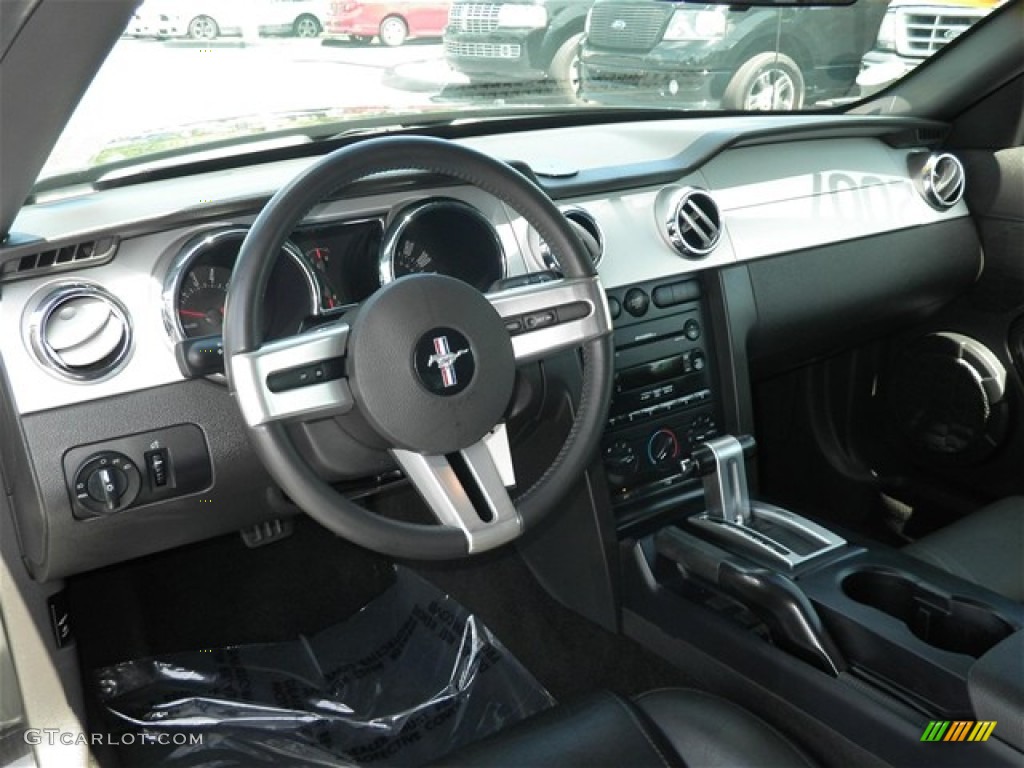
[{"x1": 347, "y1": 274, "x2": 516, "y2": 456}]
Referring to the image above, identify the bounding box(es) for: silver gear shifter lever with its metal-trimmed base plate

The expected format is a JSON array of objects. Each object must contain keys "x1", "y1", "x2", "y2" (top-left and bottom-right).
[{"x1": 680, "y1": 435, "x2": 846, "y2": 568}]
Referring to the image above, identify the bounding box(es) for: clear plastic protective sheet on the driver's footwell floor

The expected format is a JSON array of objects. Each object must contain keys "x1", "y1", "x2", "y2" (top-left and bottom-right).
[{"x1": 96, "y1": 568, "x2": 554, "y2": 768}]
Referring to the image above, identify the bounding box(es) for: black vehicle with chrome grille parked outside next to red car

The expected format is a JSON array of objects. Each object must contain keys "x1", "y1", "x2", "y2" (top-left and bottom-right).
[{"x1": 444, "y1": 0, "x2": 594, "y2": 91}]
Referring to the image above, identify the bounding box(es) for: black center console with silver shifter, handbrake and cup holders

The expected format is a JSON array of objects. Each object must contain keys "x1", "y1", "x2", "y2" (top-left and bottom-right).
[{"x1": 624, "y1": 428, "x2": 1024, "y2": 765}]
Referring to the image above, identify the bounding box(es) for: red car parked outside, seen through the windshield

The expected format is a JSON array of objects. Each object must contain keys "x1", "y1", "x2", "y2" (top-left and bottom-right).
[{"x1": 327, "y1": 0, "x2": 452, "y2": 47}]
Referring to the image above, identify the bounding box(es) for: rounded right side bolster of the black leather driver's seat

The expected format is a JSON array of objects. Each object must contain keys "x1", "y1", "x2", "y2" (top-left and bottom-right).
[{"x1": 636, "y1": 688, "x2": 814, "y2": 768}]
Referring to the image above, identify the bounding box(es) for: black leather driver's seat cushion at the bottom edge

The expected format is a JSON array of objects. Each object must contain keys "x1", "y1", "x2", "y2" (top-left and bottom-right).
[{"x1": 438, "y1": 688, "x2": 813, "y2": 768}]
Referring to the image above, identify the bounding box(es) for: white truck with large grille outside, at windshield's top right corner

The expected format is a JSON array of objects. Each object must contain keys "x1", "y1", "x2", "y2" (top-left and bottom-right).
[{"x1": 857, "y1": 0, "x2": 1002, "y2": 96}]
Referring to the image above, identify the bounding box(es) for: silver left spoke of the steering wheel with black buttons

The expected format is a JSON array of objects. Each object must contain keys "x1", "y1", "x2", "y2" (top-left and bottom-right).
[{"x1": 229, "y1": 323, "x2": 352, "y2": 427}]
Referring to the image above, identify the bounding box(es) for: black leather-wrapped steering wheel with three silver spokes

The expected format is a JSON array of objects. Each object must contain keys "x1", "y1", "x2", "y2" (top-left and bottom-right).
[{"x1": 223, "y1": 137, "x2": 612, "y2": 559}]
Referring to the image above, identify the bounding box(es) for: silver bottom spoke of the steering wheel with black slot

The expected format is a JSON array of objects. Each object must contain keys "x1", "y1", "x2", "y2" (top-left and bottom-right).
[{"x1": 391, "y1": 424, "x2": 522, "y2": 553}]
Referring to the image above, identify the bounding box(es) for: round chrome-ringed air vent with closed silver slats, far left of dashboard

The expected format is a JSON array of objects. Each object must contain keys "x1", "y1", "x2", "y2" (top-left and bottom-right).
[{"x1": 29, "y1": 284, "x2": 131, "y2": 381}]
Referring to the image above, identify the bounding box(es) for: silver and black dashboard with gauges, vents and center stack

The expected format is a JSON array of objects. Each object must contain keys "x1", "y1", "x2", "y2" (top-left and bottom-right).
[{"x1": 0, "y1": 116, "x2": 980, "y2": 575}]
